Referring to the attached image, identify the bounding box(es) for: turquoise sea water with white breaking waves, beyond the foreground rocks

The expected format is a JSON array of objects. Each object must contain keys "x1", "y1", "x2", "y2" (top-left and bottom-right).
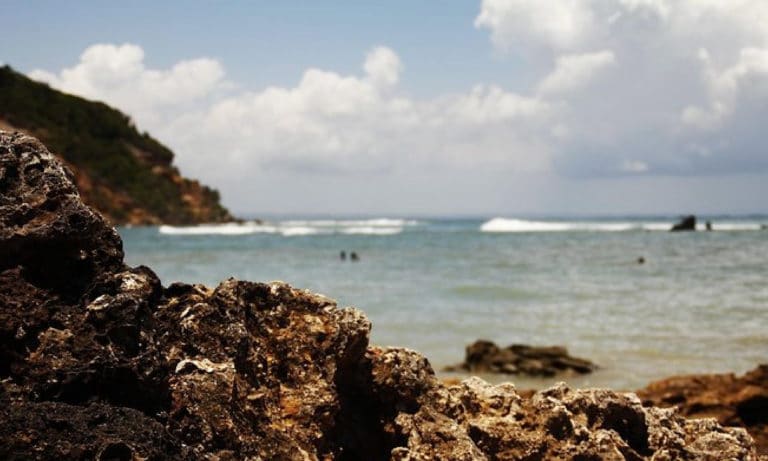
[{"x1": 120, "y1": 217, "x2": 768, "y2": 389}]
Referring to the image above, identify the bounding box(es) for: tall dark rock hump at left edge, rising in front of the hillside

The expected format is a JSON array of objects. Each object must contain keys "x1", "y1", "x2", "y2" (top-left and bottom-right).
[{"x1": 0, "y1": 132, "x2": 123, "y2": 295}]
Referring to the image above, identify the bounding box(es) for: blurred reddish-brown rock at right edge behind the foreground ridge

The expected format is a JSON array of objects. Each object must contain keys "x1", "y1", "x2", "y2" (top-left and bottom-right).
[{"x1": 637, "y1": 365, "x2": 768, "y2": 455}]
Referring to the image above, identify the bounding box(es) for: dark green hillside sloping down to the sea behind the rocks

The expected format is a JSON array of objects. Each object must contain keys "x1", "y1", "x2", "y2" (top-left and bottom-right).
[{"x1": 0, "y1": 66, "x2": 233, "y2": 224}]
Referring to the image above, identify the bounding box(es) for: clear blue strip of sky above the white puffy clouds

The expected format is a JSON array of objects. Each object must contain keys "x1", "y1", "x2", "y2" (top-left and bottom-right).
[{"x1": 3, "y1": 0, "x2": 510, "y2": 96}]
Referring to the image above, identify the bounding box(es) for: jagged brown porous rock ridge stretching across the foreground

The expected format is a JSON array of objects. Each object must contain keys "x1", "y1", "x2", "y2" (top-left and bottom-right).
[{"x1": 0, "y1": 134, "x2": 758, "y2": 460}]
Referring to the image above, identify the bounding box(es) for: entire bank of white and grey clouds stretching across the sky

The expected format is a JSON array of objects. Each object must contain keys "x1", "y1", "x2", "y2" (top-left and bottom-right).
[{"x1": 31, "y1": 0, "x2": 768, "y2": 200}]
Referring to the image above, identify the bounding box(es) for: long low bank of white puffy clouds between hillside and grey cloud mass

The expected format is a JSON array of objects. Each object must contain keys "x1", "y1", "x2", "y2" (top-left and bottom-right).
[{"x1": 30, "y1": 44, "x2": 557, "y2": 184}]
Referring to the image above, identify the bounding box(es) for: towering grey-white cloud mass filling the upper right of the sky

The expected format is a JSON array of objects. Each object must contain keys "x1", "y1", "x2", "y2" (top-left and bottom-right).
[{"x1": 475, "y1": 0, "x2": 768, "y2": 176}]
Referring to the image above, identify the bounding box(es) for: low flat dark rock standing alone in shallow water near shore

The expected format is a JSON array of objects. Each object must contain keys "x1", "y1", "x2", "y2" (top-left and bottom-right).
[{"x1": 445, "y1": 339, "x2": 597, "y2": 376}]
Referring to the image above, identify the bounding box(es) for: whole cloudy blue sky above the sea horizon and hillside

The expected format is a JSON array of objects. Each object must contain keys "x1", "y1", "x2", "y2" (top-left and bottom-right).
[{"x1": 0, "y1": 0, "x2": 768, "y2": 217}]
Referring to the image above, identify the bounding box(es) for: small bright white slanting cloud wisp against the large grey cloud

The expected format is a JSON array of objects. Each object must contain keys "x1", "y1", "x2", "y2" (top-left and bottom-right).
[{"x1": 538, "y1": 50, "x2": 616, "y2": 94}]
